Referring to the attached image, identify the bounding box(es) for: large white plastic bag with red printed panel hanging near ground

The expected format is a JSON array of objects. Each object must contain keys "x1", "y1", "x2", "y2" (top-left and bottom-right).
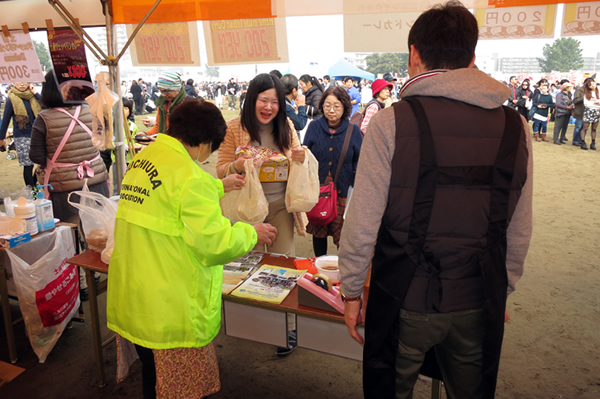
[{"x1": 7, "y1": 226, "x2": 80, "y2": 363}]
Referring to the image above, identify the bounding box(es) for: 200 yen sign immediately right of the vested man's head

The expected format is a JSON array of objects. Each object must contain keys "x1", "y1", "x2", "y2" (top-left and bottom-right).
[{"x1": 475, "y1": 5, "x2": 556, "y2": 40}]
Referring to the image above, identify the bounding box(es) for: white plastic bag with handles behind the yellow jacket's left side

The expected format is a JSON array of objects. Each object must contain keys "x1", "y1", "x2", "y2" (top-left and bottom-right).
[{"x1": 68, "y1": 184, "x2": 117, "y2": 264}]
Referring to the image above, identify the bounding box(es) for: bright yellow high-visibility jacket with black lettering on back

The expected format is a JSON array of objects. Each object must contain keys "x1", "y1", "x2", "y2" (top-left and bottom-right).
[{"x1": 107, "y1": 134, "x2": 257, "y2": 349}]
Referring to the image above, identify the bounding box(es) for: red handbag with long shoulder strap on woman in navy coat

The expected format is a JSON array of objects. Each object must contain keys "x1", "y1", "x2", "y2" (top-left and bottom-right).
[{"x1": 306, "y1": 123, "x2": 354, "y2": 226}]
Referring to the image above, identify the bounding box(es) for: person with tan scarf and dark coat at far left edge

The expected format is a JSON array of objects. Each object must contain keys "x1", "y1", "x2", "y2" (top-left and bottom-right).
[{"x1": 0, "y1": 82, "x2": 42, "y2": 188}]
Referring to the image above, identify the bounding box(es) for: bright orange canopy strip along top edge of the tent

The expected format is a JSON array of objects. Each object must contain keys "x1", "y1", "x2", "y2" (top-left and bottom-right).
[{"x1": 112, "y1": 0, "x2": 274, "y2": 24}]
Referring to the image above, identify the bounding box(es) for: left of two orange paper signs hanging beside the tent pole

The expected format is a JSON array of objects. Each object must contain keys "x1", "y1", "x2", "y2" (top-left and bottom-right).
[{"x1": 127, "y1": 21, "x2": 200, "y2": 66}]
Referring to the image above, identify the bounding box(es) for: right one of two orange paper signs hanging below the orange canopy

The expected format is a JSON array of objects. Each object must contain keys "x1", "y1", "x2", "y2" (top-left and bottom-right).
[{"x1": 203, "y1": 18, "x2": 288, "y2": 65}]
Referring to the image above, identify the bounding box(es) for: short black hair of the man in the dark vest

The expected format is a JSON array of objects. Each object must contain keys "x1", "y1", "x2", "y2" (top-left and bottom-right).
[{"x1": 408, "y1": 1, "x2": 479, "y2": 70}]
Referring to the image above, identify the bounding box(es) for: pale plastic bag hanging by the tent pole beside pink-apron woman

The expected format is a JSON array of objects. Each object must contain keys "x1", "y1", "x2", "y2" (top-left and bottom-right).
[{"x1": 85, "y1": 72, "x2": 119, "y2": 151}]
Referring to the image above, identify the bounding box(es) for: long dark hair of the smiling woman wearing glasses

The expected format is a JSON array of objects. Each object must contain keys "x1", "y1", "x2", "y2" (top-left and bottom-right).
[{"x1": 240, "y1": 73, "x2": 292, "y2": 151}]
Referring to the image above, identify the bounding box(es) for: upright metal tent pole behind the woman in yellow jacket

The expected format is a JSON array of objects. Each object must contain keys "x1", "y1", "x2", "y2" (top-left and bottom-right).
[{"x1": 102, "y1": 0, "x2": 129, "y2": 195}]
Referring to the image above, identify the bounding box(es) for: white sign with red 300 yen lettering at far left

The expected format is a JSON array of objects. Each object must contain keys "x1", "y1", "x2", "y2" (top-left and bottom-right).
[{"x1": 0, "y1": 32, "x2": 44, "y2": 83}]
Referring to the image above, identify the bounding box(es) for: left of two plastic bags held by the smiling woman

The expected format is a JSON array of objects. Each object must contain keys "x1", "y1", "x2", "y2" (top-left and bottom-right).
[{"x1": 233, "y1": 159, "x2": 269, "y2": 224}]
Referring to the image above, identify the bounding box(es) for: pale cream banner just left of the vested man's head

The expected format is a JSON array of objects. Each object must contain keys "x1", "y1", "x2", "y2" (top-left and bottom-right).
[{"x1": 344, "y1": 12, "x2": 421, "y2": 53}]
